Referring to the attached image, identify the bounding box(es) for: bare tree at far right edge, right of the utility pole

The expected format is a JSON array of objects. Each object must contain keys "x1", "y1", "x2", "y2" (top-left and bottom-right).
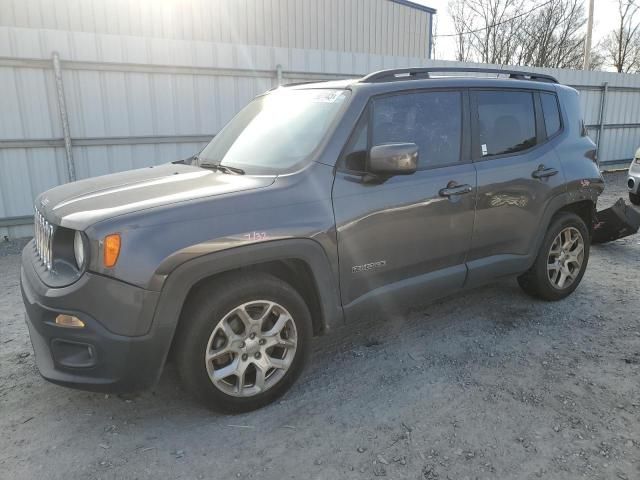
[{"x1": 603, "y1": 0, "x2": 640, "y2": 73}]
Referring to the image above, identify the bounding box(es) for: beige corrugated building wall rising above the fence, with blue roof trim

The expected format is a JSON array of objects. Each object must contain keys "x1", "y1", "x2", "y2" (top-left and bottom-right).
[{"x1": 0, "y1": 0, "x2": 431, "y2": 58}]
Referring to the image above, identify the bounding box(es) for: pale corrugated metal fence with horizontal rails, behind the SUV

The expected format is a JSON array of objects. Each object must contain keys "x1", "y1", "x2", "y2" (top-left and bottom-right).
[{"x1": 0, "y1": 27, "x2": 640, "y2": 237}]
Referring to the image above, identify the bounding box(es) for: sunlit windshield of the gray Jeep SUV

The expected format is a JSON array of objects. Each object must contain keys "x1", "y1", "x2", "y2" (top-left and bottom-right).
[{"x1": 198, "y1": 89, "x2": 350, "y2": 174}]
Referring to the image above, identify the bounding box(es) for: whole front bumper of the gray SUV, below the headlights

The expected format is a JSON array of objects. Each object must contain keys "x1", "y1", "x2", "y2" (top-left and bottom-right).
[{"x1": 20, "y1": 242, "x2": 170, "y2": 392}]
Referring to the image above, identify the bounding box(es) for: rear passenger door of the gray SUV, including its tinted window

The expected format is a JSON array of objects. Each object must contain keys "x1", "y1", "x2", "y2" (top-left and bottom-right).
[{"x1": 467, "y1": 89, "x2": 565, "y2": 284}]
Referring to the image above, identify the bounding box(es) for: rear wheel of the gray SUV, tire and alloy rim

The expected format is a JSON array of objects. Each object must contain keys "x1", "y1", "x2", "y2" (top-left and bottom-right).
[{"x1": 518, "y1": 212, "x2": 591, "y2": 301}]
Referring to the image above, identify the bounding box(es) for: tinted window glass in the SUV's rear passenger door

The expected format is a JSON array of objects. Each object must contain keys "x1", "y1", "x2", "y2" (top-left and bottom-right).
[{"x1": 476, "y1": 91, "x2": 536, "y2": 157}]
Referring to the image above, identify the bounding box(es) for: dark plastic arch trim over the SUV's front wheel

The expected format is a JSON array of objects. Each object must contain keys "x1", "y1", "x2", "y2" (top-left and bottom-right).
[{"x1": 146, "y1": 239, "x2": 344, "y2": 368}]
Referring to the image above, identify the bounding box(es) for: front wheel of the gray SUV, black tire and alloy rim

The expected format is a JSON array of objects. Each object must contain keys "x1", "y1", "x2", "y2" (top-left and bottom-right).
[{"x1": 175, "y1": 272, "x2": 313, "y2": 413}]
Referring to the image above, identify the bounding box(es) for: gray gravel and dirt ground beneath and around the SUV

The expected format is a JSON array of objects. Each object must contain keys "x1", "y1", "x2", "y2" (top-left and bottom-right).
[{"x1": 0, "y1": 174, "x2": 640, "y2": 480}]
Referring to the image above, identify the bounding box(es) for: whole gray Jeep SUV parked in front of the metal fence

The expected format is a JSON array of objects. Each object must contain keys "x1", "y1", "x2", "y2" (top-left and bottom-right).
[{"x1": 21, "y1": 68, "x2": 603, "y2": 412}]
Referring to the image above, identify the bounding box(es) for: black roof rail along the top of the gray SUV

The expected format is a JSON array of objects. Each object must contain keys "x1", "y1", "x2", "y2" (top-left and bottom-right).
[{"x1": 360, "y1": 67, "x2": 559, "y2": 83}]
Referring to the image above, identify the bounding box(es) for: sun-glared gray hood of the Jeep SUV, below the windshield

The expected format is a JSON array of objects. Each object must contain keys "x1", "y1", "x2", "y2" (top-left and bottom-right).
[{"x1": 36, "y1": 164, "x2": 275, "y2": 230}]
